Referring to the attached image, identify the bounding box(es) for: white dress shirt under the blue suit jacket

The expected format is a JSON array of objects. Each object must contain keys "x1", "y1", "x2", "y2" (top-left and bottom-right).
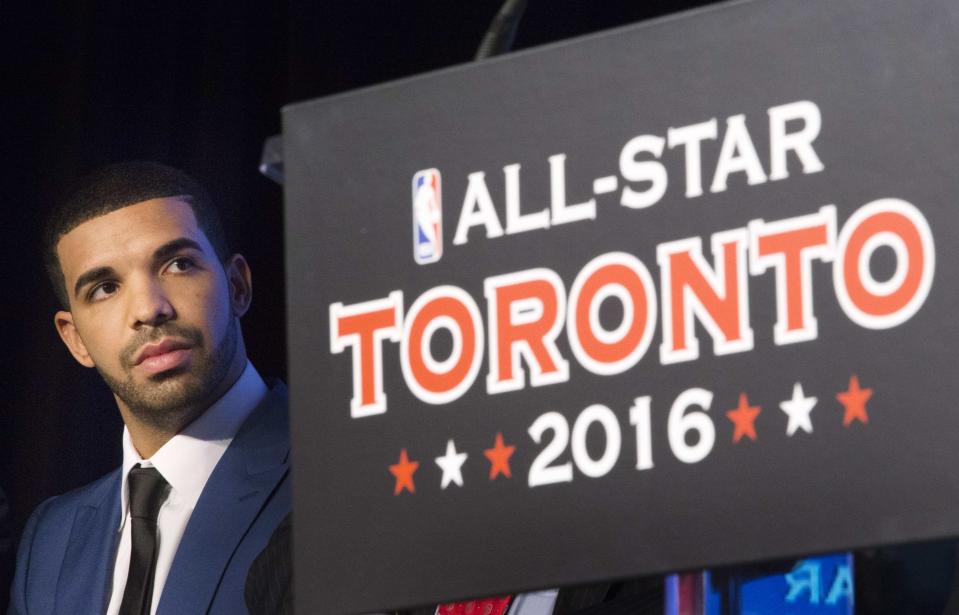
[{"x1": 107, "y1": 362, "x2": 267, "y2": 615}]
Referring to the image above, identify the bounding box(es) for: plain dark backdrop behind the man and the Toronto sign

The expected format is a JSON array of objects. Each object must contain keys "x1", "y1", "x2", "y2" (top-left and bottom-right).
[{"x1": 0, "y1": 0, "x2": 711, "y2": 609}]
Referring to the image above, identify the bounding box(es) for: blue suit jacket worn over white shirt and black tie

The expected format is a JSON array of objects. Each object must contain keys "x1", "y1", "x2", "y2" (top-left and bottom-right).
[{"x1": 8, "y1": 383, "x2": 290, "y2": 615}]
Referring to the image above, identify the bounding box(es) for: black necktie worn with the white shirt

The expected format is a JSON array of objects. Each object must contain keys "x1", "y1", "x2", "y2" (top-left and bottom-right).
[{"x1": 120, "y1": 464, "x2": 168, "y2": 615}]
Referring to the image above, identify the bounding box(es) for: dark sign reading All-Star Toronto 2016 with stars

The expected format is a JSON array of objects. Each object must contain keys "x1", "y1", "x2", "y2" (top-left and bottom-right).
[{"x1": 283, "y1": 0, "x2": 959, "y2": 613}]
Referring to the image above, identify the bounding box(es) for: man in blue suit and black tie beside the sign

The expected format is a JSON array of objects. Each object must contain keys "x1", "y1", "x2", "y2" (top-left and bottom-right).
[{"x1": 9, "y1": 163, "x2": 290, "y2": 615}]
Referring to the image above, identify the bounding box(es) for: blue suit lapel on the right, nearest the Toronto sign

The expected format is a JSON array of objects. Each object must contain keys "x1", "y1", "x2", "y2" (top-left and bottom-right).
[{"x1": 157, "y1": 383, "x2": 290, "y2": 615}]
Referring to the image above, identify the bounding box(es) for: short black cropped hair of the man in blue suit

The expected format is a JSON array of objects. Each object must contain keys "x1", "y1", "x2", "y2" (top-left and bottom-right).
[{"x1": 43, "y1": 161, "x2": 230, "y2": 310}]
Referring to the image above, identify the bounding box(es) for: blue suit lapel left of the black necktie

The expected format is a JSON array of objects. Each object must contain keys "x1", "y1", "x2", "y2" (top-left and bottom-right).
[{"x1": 55, "y1": 471, "x2": 120, "y2": 613}]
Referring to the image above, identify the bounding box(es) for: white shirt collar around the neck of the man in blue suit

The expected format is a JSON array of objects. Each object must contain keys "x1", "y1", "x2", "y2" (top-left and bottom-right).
[{"x1": 120, "y1": 361, "x2": 267, "y2": 526}]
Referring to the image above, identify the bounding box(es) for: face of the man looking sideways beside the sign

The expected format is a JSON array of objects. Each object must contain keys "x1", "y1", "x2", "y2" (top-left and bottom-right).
[{"x1": 56, "y1": 197, "x2": 250, "y2": 431}]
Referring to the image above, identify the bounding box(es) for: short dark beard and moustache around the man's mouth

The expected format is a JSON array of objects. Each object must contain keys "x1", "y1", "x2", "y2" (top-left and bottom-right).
[{"x1": 97, "y1": 317, "x2": 238, "y2": 433}]
